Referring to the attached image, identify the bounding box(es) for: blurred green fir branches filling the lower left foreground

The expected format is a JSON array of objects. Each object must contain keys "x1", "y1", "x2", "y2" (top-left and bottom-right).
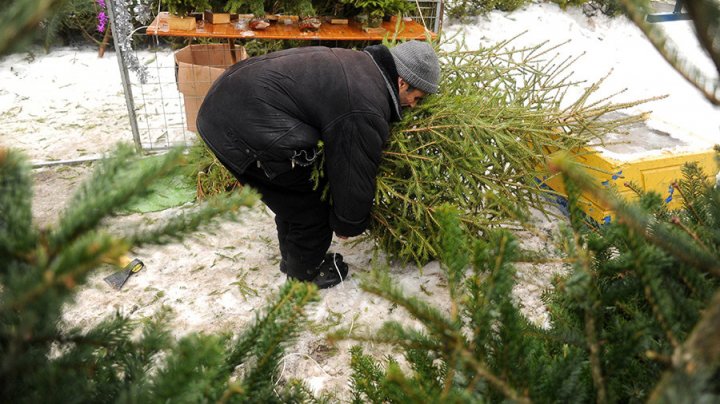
[{"x1": 0, "y1": 146, "x2": 326, "y2": 403}]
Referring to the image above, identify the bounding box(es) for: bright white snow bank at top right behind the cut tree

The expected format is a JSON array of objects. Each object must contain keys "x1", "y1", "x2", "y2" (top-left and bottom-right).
[{"x1": 445, "y1": 3, "x2": 720, "y2": 161}]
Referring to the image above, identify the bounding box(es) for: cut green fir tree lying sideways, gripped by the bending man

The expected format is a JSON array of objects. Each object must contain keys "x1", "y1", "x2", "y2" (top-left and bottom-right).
[{"x1": 369, "y1": 36, "x2": 660, "y2": 264}]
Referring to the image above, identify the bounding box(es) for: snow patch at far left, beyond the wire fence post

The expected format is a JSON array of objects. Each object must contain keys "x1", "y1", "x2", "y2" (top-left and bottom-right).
[{"x1": 0, "y1": 48, "x2": 132, "y2": 160}]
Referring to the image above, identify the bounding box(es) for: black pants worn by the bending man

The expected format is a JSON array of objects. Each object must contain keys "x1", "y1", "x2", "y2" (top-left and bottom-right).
[{"x1": 235, "y1": 162, "x2": 333, "y2": 280}]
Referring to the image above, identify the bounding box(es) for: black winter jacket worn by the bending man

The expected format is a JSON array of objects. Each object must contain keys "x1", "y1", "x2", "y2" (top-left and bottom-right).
[{"x1": 197, "y1": 45, "x2": 401, "y2": 236}]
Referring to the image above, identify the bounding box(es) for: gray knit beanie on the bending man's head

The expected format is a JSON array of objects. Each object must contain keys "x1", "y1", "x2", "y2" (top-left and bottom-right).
[{"x1": 390, "y1": 41, "x2": 440, "y2": 94}]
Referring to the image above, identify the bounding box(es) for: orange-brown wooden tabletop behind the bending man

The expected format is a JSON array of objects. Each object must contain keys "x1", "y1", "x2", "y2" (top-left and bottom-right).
[{"x1": 146, "y1": 12, "x2": 436, "y2": 41}]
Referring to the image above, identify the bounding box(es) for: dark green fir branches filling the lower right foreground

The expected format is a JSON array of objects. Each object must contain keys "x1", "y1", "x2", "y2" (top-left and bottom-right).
[{"x1": 338, "y1": 158, "x2": 720, "y2": 403}]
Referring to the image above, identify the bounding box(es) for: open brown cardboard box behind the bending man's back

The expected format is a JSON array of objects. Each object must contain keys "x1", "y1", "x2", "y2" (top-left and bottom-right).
[{"x1": 175, "y1": 44, "x2": 247, "y2": 132}]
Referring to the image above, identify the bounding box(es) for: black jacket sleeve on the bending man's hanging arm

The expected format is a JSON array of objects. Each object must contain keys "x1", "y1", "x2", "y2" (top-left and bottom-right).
[{"x1": 323, "y1": 113, "x2": 390, "y2": 236}]
